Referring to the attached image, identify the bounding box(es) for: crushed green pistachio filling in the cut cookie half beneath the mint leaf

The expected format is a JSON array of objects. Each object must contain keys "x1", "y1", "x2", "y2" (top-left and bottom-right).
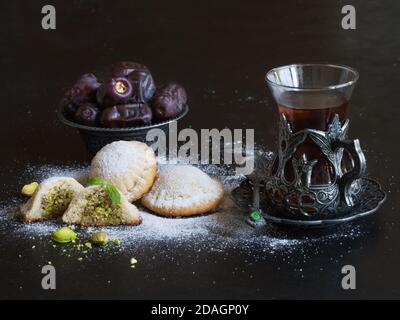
[{"x1": 82, "y1": 187, "x2": 121, "y2": 224}]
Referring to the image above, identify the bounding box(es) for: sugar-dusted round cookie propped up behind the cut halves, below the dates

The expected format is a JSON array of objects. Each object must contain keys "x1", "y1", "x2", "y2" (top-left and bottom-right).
[{"x1": 90, "y1": 141, "x2": 157, "y2": 202}]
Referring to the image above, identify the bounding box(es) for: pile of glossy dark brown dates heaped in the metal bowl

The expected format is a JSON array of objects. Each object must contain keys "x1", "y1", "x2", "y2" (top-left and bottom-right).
[{"x1": 61, "y1": 62, "x2": 187, "y2": 128}]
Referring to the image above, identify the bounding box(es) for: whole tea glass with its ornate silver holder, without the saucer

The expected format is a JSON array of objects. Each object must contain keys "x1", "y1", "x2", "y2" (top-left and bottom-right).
[{"x1": 266, "y1": 64, "x2": 366, "y2": 219}]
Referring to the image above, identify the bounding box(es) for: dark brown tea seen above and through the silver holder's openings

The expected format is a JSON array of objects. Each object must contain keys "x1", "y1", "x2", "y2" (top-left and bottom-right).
[{"x1": 278, "y1": 91, "x2": 351, "y2": 185}]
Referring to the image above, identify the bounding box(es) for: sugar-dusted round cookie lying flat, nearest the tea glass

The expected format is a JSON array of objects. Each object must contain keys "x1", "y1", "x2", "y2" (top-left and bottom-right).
[{"x1": 142, "y1": 165, "x2": 224, "y2": 217}]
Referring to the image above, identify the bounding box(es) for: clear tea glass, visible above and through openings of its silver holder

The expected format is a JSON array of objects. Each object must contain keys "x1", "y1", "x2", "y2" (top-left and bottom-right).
[{"x1": 266, "y1": 64, "x2": 358, "y2": 185}]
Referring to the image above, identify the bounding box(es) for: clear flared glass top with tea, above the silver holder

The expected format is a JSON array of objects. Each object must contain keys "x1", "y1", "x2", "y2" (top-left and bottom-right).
[{"x1": 266, "y1": 64, "x2": 358, "y2": 132}]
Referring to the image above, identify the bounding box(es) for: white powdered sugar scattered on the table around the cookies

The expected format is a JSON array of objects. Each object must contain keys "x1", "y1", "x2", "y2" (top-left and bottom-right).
[{"x1": 0, "y1": 152, "x2": 361, "y2": 254}]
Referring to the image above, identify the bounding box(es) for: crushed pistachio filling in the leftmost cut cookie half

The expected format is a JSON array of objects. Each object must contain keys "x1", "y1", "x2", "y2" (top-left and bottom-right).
[{"x1": 42, "y1": 186, "x2": 73, "y2": 217}]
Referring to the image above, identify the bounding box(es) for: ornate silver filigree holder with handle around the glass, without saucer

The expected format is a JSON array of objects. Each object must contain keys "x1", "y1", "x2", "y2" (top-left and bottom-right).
[{"x1": 266, "y1": 114, "x2": 366, "y2": 219}]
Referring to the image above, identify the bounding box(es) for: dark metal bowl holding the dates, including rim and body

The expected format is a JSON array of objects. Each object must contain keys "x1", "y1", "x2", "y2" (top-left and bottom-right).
[{"x1": 58, "y1": 105, "x2": 189, "y2": 157}]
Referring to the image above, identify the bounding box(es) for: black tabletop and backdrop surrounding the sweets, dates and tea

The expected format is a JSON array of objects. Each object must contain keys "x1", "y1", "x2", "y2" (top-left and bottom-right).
[{"x1": 0, "y1": 0, "x2": 400, "y2": 299}]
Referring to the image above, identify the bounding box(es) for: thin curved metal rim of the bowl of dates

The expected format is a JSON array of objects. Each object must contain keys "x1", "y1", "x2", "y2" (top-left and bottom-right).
[{"x1": 57, "y1": 104, "x2": 189, "y2": 133}]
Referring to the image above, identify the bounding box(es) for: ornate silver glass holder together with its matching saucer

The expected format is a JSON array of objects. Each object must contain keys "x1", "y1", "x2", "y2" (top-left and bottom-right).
[{"x1": 231, "y1": 114, "x2": 386, "y2": 227}]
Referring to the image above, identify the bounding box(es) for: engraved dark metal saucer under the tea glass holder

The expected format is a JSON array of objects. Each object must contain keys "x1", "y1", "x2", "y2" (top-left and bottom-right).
[{"x1": 231, "y1": 178, "x2": 386, "y2": 228}]
